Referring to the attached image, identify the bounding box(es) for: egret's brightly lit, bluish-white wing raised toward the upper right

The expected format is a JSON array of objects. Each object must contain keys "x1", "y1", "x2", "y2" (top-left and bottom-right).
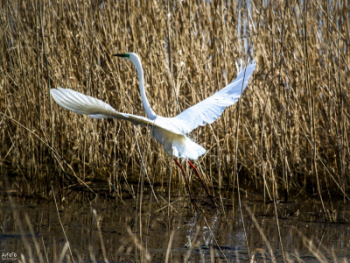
[{"x1": 172, "y1": 61, "x2": 256, "y2": 134}]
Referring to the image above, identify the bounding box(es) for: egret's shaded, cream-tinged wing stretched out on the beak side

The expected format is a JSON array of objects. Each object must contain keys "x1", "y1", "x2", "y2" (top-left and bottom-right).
[{"x1": 50, "y1": 87, "x2": 176, "y2": 133}]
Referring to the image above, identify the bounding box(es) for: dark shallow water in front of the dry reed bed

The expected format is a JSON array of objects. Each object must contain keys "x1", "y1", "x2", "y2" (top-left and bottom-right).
[{"x1": 0, "y1": 185, "x2": 350, "y2": 262}]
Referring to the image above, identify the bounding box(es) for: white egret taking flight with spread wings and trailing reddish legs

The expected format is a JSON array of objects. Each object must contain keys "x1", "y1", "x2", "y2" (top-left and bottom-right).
[{"x1": 50, "y1": 53, "x2": 256, "y2": 204}]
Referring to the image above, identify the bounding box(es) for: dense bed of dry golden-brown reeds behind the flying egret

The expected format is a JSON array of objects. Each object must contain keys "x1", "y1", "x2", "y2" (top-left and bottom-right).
[{"x1": 0, "y1": 0, "x2": 350, "y2": 197}]
